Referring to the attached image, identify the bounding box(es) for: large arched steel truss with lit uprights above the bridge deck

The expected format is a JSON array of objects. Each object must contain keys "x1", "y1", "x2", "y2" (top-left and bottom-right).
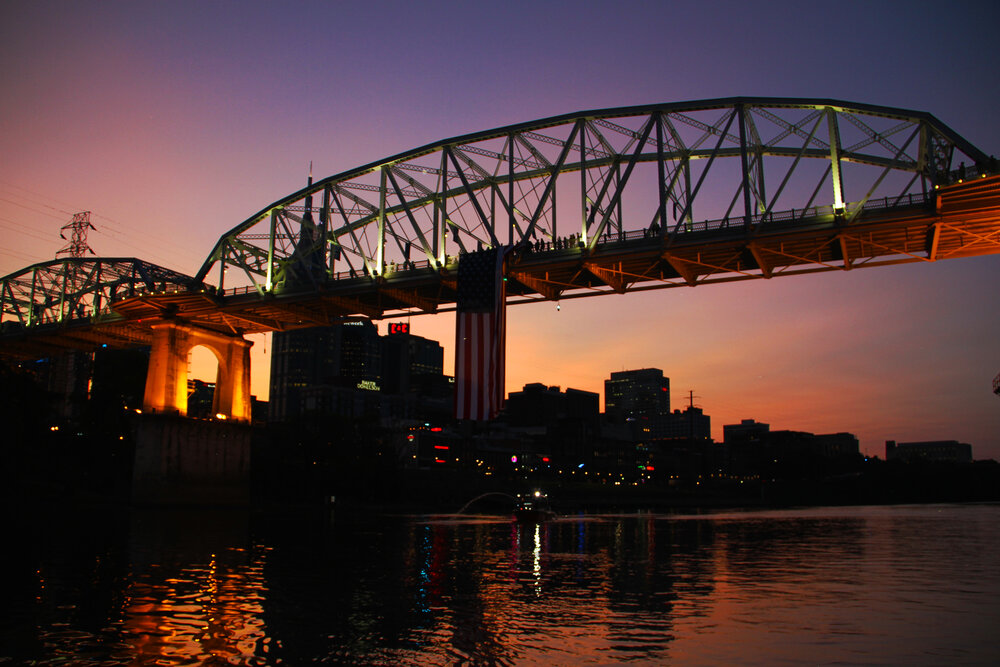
[{"x1": 195, "y1": 98, "x2": 996, "y2": 295}]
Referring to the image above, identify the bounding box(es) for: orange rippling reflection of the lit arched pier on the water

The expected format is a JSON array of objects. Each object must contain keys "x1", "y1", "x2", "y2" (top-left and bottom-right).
[{"x1": 121, "y1": 512, "x2": 270, "y2": 665}]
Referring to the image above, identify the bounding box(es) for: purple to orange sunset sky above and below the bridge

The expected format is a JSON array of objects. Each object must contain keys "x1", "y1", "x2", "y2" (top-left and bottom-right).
[{"x1": 0, "y1": 0, "x2": 1000, "y2": 459}]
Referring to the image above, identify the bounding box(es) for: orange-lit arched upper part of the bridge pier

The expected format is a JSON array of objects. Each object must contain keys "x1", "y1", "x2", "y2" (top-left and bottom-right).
[{"x1": 143, "y1": 322, "x2": 253, "y2": 421}]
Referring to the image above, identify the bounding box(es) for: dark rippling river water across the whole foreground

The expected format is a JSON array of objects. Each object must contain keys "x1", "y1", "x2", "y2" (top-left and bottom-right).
[{"x1": 0, "y1": 504, "x2": 1000, "y2": 665}]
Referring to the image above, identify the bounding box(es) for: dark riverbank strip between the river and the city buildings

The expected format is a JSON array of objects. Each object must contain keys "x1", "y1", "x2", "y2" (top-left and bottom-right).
[{"x1": 3, "y1": 434, "x2": 1000, "y2": 513}]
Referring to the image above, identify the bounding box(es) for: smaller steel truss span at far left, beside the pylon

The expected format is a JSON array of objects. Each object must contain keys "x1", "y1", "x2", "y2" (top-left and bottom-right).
[{"x1": 0, "y1": 257, "x2": 193, "y2": 333}]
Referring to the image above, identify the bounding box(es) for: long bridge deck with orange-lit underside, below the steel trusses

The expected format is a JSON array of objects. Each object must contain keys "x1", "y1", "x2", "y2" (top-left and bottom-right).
[{"x1": 0, "y1": 176, "x2": 1000, "y2": 357}]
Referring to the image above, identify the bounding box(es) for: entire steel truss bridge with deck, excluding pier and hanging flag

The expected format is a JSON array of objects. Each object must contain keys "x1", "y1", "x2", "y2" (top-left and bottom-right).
[{"x1": 0, "y1": 98, "x2": 1000, "y2": 356}]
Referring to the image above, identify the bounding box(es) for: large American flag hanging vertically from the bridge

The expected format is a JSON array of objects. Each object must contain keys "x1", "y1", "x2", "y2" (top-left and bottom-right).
[{"x1": 455, "y1": 248, "x2": 507, "y2": 419}]
